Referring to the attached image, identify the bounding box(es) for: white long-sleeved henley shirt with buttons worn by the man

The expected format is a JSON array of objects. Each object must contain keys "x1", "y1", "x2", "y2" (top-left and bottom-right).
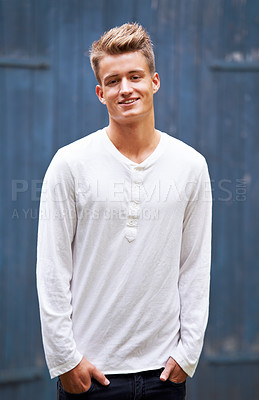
[{"x1": 37, "y1": 129, "x2": 211, "y2": 378}]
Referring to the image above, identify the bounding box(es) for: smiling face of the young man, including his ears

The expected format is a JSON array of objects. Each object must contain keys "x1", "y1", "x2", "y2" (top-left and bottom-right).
[{"x1": 96, "y1": 51, "x2": 160, "y2": 124}]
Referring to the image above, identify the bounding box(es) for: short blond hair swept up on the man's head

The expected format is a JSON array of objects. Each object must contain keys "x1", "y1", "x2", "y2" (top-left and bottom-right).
[{"x1": 90, "y1": 23, "x2": 155, "y2": 84}]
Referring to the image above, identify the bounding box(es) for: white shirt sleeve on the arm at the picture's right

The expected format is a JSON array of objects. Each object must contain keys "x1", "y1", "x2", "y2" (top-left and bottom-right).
[{"x1": 172, "y1": 160, "x2": 212, "y2": 377}]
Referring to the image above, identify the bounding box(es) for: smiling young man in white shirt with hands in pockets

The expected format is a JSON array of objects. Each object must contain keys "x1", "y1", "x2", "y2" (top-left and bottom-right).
[{"x1": 37, "y1": 24, "x2": 211, "y2": 400}]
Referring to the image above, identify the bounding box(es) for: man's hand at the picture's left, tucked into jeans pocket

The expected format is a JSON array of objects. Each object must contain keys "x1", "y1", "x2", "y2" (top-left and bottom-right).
[{"x1": 60, "y1": 358, "x2": 110, "y2": 394}]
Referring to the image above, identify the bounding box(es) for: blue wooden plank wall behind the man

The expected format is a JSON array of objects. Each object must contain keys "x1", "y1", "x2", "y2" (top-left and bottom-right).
[{"x1": 0, "y1": 0, "x2": 259, "y2": 400}]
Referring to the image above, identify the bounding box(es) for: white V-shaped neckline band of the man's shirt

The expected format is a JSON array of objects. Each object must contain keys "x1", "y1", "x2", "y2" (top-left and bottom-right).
[{"x1": 103, "y1": 128, "x2": 164, "y2": 167}]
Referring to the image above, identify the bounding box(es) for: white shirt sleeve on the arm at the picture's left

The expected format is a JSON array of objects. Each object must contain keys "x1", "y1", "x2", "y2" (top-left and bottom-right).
[{"x1": 37, "y1": 151, "x2": 82, "y2": 378}]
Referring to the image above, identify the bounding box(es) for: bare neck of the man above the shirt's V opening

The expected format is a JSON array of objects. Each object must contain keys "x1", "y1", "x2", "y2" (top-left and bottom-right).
[{"x1": 106, "y1": 121, "x2": 160, "y2": 164}]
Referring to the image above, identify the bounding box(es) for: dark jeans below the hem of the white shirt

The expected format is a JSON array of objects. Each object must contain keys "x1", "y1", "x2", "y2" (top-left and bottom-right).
[{"x1": 57, "y1": 368, "x2": 186, "y2": 400}]
